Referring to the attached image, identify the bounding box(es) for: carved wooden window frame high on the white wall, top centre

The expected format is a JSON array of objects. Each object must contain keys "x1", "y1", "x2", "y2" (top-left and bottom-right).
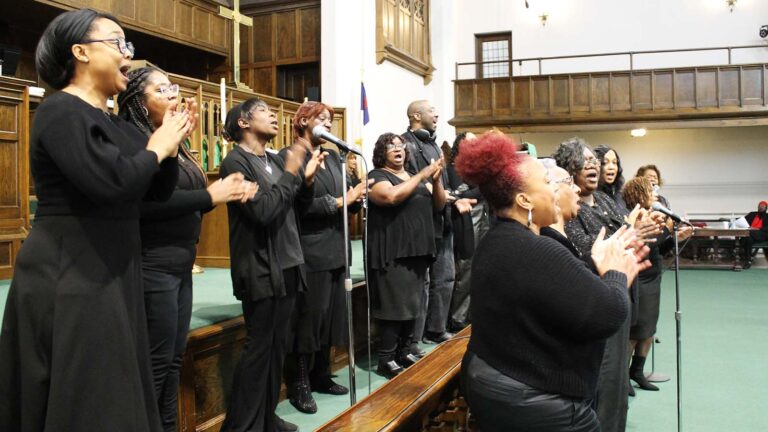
[{"x1": 376, "y1": 0, "x2": 435, "y2": 83}]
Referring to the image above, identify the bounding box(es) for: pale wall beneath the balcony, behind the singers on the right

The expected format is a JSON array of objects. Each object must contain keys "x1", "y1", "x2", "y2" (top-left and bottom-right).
[{"x1": 518, "y1": 126, "x2": 768, "y2": 214}]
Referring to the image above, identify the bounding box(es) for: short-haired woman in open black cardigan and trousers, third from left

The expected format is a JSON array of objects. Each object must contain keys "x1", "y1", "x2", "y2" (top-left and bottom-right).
[{"x1": 219, "y1": 98, "x2": 325, "y2": 432}]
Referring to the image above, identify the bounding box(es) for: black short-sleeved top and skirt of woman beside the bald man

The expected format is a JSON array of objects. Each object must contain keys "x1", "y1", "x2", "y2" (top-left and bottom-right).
[{"x1": 368, "y1": 169, "x2": 435, "y2": 321}]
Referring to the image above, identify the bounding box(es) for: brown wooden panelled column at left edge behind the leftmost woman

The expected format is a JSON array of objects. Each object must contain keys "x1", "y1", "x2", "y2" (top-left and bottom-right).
[{"x1": 0, "y1": 76, "x2": 34, "y2": 279}]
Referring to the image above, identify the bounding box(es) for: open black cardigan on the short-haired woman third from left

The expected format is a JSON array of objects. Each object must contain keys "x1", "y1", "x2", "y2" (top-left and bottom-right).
[{"x1": 219, "y1": 147, "x2": 313, "y2": 301}]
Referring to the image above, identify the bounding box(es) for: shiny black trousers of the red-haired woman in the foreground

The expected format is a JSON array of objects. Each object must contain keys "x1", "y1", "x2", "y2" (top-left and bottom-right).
[{"x1": 461, "y1": 351, "x2": 600, "y2": 432}]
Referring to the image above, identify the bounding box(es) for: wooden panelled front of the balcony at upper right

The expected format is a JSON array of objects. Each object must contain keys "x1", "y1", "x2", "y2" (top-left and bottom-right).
[{"x1": 450, "y1": 64, "x2": 768, "y2": 131}]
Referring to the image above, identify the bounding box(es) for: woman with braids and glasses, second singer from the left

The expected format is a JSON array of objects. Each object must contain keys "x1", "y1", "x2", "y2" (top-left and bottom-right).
[{"x1": 117, "y1": 67, "x2": 256, "y2": 432}]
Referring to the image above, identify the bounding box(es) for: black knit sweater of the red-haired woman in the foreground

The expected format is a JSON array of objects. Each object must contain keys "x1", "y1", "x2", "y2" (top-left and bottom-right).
[{"x1": 469, "y1": 218, "x2": 629, "y2": 399}]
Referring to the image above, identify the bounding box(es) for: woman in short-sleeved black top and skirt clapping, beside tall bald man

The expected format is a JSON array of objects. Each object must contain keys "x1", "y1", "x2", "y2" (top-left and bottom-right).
[{"x1": 367, "y1": 133, "x2": 445, "y2": 378}]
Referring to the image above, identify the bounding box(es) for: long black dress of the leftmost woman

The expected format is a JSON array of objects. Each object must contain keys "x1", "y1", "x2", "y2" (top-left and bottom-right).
[{"x1": 0, "y1": 92, "x2": 178, "y2": 432}]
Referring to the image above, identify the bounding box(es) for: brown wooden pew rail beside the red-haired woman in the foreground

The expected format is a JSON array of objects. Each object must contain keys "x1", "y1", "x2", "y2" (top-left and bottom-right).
[{"x1": 318, "y1": 326, "x2": 472, "y2": 432}]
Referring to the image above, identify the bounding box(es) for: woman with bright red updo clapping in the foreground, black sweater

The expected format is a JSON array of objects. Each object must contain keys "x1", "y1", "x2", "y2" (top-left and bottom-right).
[{"x1": 456, "y1": 133, "x2": 640, "y2": 432}]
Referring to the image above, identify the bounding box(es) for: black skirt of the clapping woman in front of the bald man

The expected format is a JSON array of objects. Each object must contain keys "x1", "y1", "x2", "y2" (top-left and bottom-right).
[{"x1": 368, "y1": 256, "x2": 432, "y2": 321}]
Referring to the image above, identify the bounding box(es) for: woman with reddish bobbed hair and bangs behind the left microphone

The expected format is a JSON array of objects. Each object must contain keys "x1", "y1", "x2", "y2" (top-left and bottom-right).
[{"x1": 281, "y1": 101, "x2": 365, "y2": 414}]
